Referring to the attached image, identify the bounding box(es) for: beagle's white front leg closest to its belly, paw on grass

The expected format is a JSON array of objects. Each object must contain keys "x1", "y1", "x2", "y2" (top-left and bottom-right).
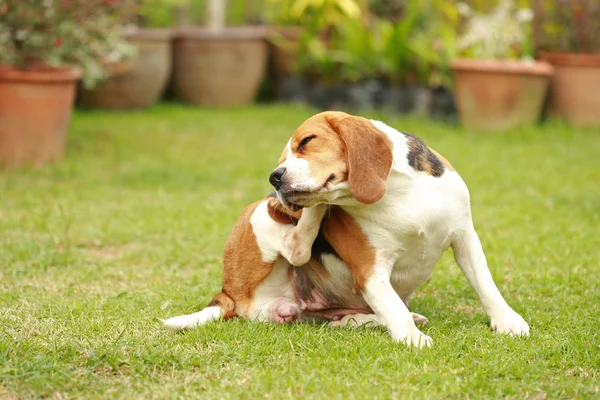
[{"x1": 363, "y1": 262, "x2": 433, "y2": 347}]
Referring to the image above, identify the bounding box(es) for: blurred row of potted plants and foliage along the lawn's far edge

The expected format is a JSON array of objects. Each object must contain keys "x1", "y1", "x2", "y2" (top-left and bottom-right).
[{"x1": 0, "y1": 0, "x2": 600, "y2": 164}]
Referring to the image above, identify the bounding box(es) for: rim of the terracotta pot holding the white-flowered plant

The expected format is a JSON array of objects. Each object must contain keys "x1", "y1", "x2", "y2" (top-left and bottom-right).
[{"x1": 451, "y1": 58, "x2": 554, "y2": 76}]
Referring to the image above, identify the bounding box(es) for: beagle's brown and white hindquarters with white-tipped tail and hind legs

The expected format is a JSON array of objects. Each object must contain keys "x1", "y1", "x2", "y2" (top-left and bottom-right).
[{"x1": 163, "y1": 197, "x2": 427, "y2": 330}]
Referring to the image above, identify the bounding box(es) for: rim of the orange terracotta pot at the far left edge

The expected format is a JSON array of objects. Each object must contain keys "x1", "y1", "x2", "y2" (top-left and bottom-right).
[{"x1": 0, "y1": 64, "x2": 82, "y2": 83}]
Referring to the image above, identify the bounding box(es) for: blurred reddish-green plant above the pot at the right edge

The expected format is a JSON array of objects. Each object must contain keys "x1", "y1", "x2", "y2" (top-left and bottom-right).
[{"x1": 537, "y1": 0, "x2": 600, "y2": 53}]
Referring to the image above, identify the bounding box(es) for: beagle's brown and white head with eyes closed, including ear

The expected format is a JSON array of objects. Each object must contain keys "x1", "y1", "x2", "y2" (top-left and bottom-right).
[{"x1": 269, "y1": 111, "x2": 393, "y2": 210}]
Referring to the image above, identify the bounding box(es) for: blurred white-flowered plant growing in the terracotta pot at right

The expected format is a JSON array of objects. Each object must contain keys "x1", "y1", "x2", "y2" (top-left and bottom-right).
[{"x1": 457, "y1": 0, "x2": 534, "y2": 60}]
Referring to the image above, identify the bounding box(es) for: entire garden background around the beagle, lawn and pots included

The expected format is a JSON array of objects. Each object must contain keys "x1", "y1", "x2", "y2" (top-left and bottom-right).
[{"x1": 0, "y1": 6, "x2": 600, "y2": 399}]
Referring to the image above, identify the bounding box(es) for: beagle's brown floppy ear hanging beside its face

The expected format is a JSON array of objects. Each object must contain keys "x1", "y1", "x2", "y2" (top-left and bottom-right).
[{"x1": 325, "y1": 112, "x2": 393, "y2": 204}]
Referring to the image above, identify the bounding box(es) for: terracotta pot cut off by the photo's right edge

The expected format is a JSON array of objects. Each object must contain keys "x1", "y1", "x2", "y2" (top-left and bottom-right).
[{"x1": 541, "y1": 53, "x2": 600, "y2": 126}]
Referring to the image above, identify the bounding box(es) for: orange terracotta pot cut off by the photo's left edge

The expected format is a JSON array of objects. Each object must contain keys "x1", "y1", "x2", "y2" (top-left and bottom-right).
[{"x1": 0, "y1": 66, "x2": 81, "y2": 167}]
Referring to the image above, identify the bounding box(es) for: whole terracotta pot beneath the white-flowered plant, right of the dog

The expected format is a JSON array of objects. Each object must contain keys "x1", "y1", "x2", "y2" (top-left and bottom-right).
[{"x1": 452, "y1": 59, "x2": 553, "y2": 130}]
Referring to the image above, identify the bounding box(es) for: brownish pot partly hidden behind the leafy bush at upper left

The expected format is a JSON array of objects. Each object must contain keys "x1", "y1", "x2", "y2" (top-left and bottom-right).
[{"x1": 78, "y1": 29, "x2": 173, "y2": 109}]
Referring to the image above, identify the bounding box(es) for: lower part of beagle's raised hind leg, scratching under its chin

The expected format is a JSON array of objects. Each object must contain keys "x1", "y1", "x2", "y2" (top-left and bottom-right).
[{"x1": 281, "y1": 204, "x2": 328, "y2": 266}]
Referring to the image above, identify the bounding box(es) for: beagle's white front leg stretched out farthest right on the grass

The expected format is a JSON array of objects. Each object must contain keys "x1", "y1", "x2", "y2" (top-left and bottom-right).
[{"x1": 452, "y1": 225, "x2": 529, "y2": 335}]
